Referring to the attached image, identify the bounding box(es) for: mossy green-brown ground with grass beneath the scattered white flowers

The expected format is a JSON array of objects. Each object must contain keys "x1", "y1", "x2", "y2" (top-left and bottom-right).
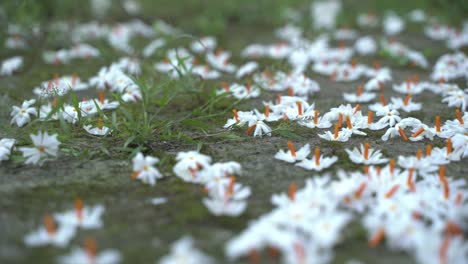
[{"x1": 0, "y1": 1, "x2": 468, "y2": 263}]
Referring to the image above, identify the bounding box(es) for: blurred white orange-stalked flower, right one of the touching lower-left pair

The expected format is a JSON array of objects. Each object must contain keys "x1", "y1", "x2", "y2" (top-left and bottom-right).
[{"x1": 54, "y1": 199, "x2": 104, "y2": 229}]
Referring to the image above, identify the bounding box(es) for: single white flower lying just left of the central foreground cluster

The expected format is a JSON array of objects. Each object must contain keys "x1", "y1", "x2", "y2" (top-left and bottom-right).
[{"x1": 132, "y1": 152, "x2": 163, "y2": 185}]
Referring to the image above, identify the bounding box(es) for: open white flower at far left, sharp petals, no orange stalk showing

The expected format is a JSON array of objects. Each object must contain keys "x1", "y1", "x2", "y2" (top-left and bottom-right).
[{"x1": 19, "y1": 131, "x2": 60, "y2": 165}]
